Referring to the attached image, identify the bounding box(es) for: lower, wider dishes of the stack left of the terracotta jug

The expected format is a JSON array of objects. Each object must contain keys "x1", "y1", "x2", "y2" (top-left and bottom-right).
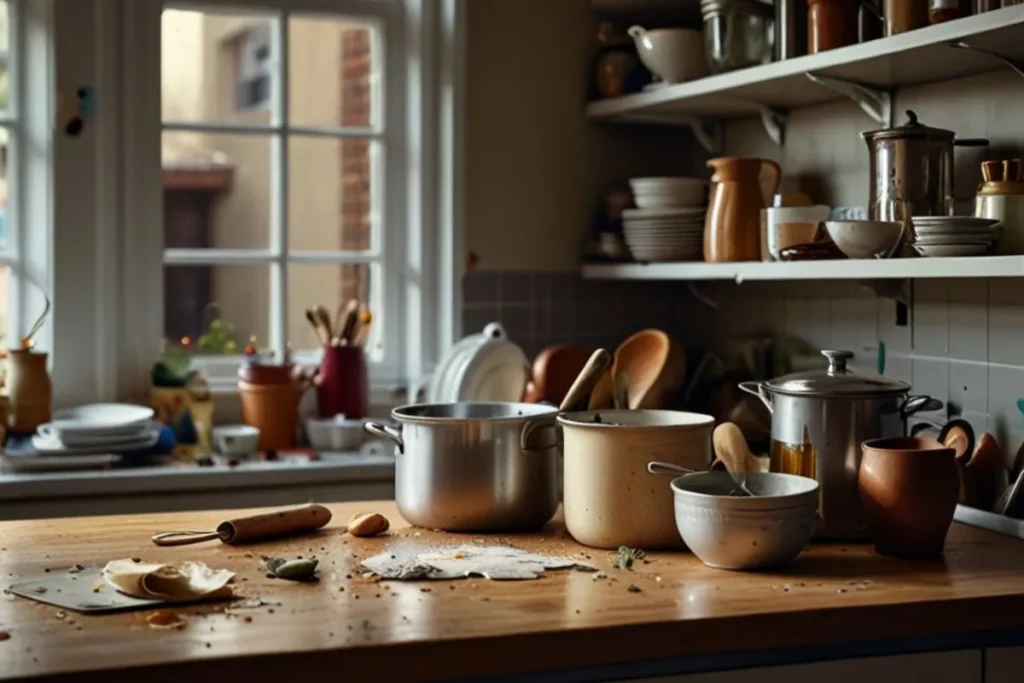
[{"x1": 623, "y1": 209, "x2": 705, "y2": 261}]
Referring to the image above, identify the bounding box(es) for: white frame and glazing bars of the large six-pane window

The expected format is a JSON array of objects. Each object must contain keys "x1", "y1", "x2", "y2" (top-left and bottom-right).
[{"x1": 121, "y1": 0, "x2": 417, "y2": 391}]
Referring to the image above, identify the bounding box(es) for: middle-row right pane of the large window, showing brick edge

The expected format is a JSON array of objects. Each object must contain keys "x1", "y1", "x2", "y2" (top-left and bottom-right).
[{"x1": 288, "y1": 136, "x2": 377, "y2": 251}]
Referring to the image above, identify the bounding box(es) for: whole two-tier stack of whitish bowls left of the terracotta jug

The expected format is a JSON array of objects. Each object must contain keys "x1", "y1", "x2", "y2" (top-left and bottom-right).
[{"x1": 623, "y1": 178, "x2": 706, "y2": 261}]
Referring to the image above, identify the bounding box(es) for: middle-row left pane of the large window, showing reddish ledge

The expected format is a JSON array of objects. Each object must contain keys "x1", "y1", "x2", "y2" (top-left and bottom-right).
[{"x1": 163, "y1": 132, "x2": 270, "y2": 249}]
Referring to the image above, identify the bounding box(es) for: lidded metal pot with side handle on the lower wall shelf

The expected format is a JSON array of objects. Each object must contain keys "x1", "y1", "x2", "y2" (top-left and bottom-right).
[{"x1": 861, "y1": 110, "x2": 988, "y2": 220}]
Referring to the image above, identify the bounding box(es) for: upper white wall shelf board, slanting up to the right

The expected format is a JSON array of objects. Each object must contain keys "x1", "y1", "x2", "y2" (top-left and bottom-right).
[{"x1": 587, "y1": 5, "x2": 1024, "y2": 124}]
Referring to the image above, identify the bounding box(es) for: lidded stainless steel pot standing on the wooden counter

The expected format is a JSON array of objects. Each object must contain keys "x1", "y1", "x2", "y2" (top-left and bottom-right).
[{"x1": 739, "y1": 350, "x2": 942, "y2": 539}]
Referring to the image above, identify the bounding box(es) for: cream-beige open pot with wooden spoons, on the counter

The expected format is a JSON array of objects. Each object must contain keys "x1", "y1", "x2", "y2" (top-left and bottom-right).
[{"x1": 558, "y1": 411, "x2": 715, "y2": 550}]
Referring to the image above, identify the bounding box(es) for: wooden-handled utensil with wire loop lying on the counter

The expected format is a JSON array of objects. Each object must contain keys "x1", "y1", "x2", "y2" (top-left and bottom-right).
[{"x1": 153, "y1": 503, "x2": 331, "y2": 546}]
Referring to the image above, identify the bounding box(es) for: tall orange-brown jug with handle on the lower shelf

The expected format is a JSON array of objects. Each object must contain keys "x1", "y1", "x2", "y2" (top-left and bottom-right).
[{"x1": 705, "y1": 157, "x2": 782, "y2": 263}]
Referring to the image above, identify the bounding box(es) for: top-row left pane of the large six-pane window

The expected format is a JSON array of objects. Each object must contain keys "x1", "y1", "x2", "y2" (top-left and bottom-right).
[{"x1": 161, "y1": 9, "x2": 274, "y2": 124}]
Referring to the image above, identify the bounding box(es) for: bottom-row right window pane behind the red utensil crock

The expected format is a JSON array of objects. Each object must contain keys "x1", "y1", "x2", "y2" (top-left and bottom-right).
[{"x1": 288, "y1": 263, "x2": 372, "y2": 349}]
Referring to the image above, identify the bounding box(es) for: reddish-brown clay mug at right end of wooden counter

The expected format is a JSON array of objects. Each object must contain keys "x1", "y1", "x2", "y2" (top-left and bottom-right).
[{"x1": 857, "y1": 437, "x2": 959, "y2": 557}]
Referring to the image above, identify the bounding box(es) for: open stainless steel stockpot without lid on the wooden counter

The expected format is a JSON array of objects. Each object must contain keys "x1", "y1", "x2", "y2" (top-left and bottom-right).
[{"x1": 366, "y1": 402, "x2": 561, "y2": 531}]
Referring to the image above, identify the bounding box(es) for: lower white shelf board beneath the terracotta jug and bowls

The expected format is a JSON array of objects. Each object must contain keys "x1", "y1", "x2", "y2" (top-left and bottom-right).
[{"x1": 583, "y1": 256, "x2": 1024, "y2": 283}]
